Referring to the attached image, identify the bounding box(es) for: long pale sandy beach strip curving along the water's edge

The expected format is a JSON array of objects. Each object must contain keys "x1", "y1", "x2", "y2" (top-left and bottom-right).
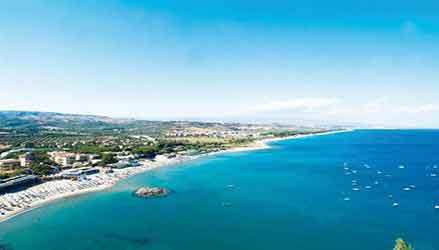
[{"x1": 0, "y1": 129, "x2": 353, "y2": 223}]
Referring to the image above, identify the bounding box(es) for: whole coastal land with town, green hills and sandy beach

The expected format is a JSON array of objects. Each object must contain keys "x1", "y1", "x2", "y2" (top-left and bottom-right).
[{"x1": 0, "y1": 113, "x2": 337, "y2": 220}]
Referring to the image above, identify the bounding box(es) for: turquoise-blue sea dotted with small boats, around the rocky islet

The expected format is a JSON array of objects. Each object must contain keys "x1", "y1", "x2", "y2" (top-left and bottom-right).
[{"x1": 0, "y1": 130, "x2": 439, "y2": 250}]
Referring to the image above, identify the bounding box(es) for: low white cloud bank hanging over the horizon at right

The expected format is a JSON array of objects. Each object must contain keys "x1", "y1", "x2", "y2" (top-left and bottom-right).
[{"x1": 226, "y1": 96, "x2": 439, "y2": 127}]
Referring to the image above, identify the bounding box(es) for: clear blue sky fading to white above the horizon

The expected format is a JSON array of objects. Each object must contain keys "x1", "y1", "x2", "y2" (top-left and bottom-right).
[{"x1": 0, "y1": 0, "x2": 439, "y2": 128}]
